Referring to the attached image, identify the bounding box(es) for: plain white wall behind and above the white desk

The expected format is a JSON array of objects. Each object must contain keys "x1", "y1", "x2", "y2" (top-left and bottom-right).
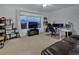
[{"x1": 48, "y1": 6, "x2": 79, "y2": 33}]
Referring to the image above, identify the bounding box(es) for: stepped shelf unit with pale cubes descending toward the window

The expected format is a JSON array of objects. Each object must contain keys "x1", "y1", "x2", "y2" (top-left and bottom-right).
[{"x1": 6, "y1": 19, "x2": 20, "y2": 40}]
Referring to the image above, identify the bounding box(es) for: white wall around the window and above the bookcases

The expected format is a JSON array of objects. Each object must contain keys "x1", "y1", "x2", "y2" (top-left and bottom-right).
[{"x1": 0, "y1": 5, "x2": 43, "y2": 36}]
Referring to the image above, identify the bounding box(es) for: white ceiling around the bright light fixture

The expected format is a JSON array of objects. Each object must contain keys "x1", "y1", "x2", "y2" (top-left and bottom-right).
[{"x1": 6, "y1": 4, "x2": 77, "y2": 13}]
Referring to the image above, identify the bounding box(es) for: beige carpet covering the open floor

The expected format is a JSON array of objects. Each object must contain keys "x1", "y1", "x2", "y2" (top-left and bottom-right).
[{"x1": 0, "y1": 33, "x2": 59, "y2": 55}]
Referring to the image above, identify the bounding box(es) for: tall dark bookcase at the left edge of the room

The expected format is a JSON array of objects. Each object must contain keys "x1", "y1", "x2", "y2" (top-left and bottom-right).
[{"x1": 0, "y1": 17, "x2": 6, "y2": 48}]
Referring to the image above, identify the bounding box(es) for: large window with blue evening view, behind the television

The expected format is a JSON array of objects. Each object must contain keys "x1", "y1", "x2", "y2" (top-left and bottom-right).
[{"x1": 19, "y1": 16, "x2": 41, "y2": 29}]
